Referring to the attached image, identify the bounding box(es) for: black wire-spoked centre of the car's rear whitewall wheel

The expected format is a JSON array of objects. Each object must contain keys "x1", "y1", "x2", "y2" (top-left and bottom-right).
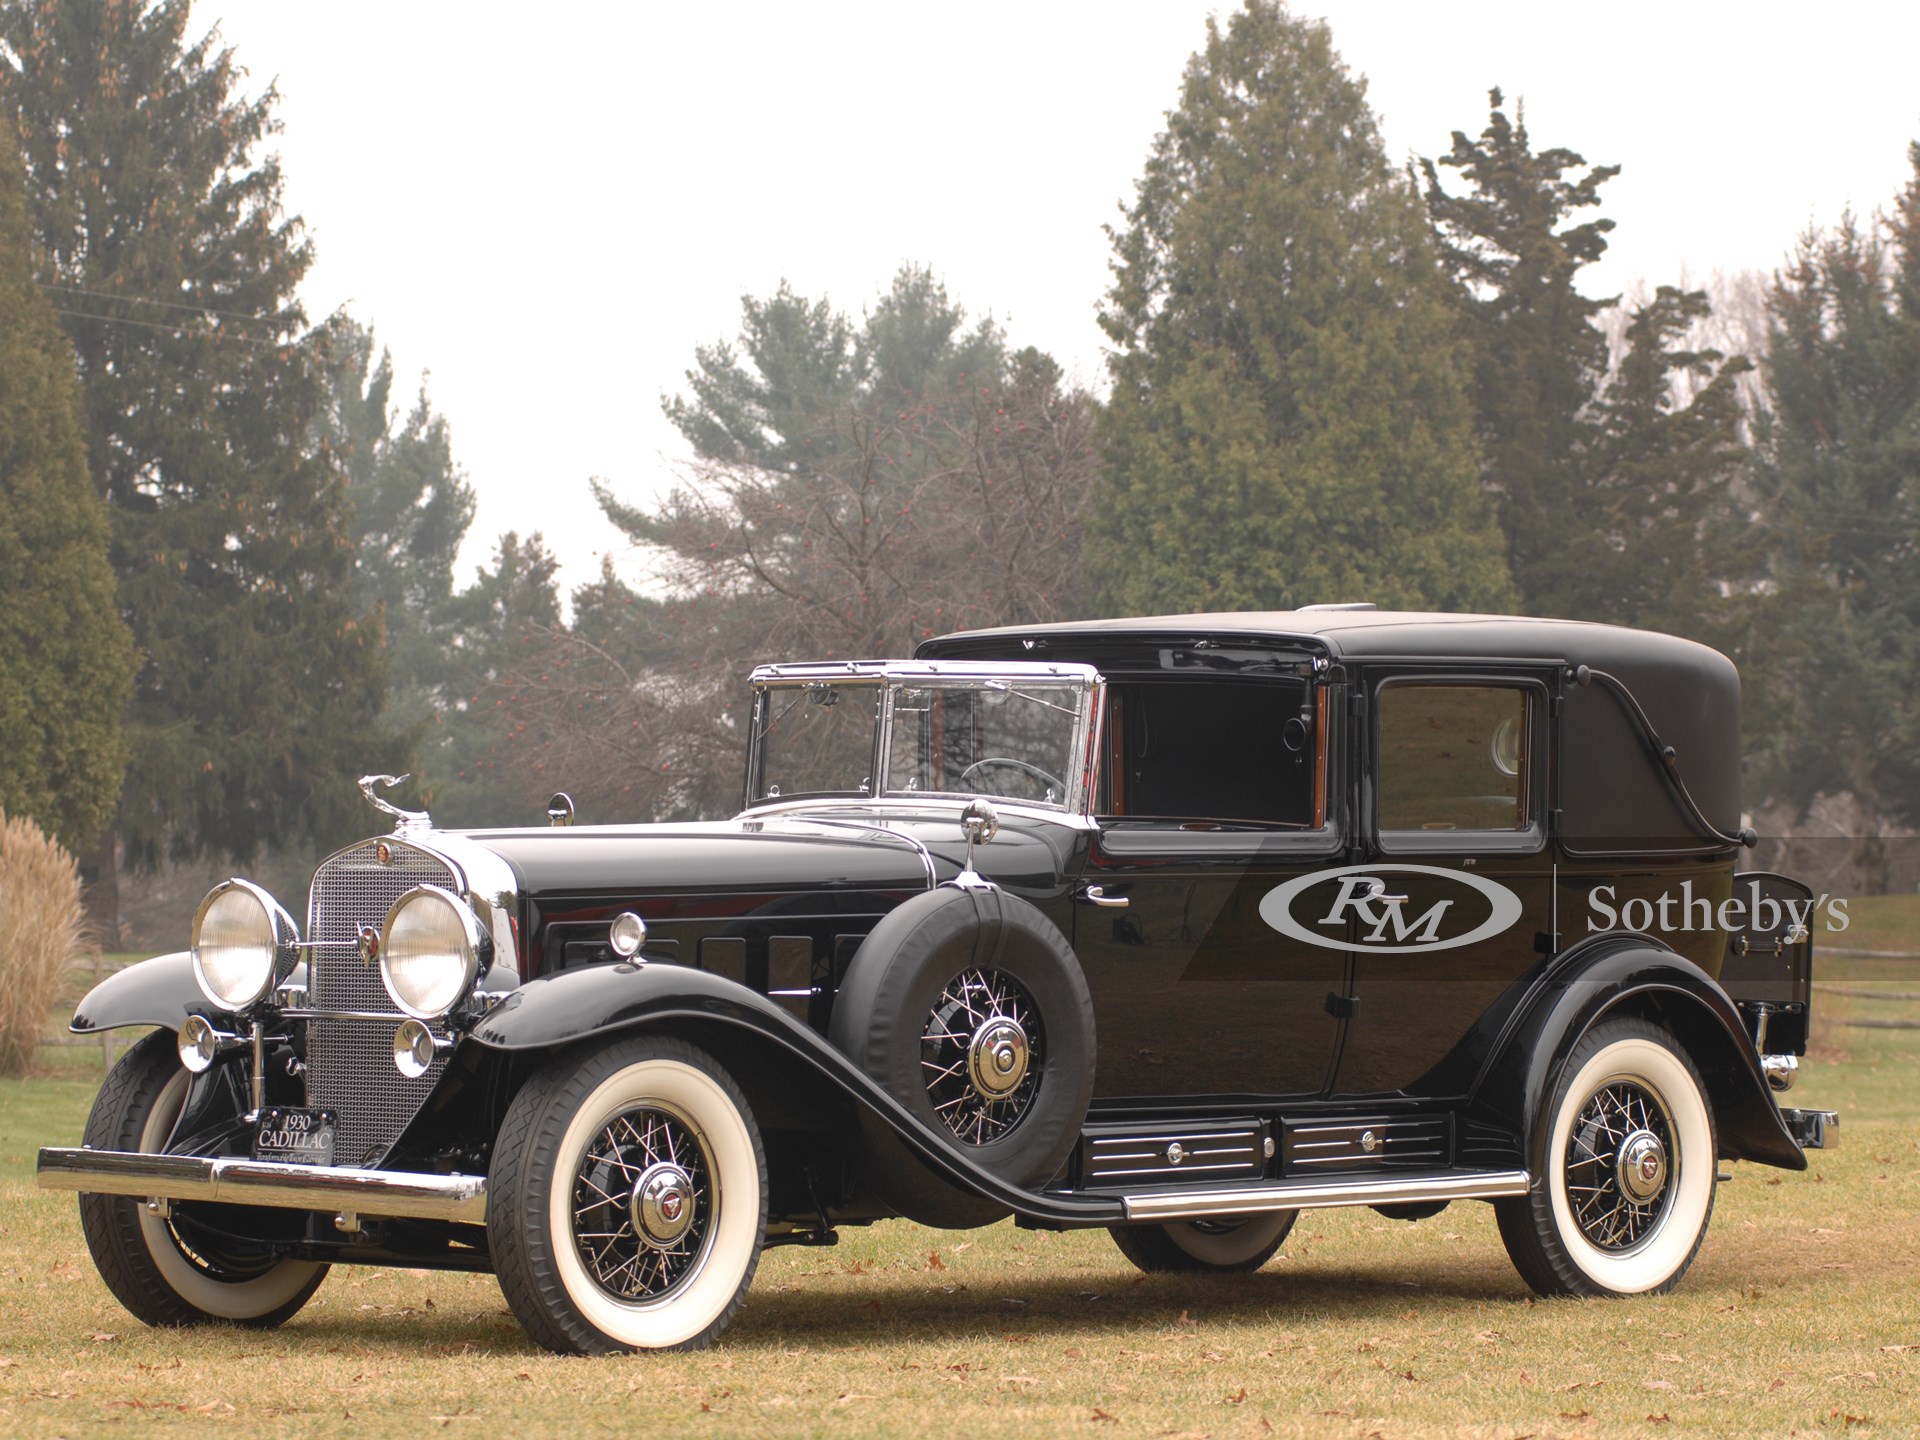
[{"x1": 1563, "y1": 1079, "x2": 1674, "y2": 1254}]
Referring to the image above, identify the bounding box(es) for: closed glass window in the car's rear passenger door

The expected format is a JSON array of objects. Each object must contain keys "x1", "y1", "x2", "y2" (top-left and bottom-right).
[{"x1": 1375, "y1": 682, "x2": 1532, "y2": 833}]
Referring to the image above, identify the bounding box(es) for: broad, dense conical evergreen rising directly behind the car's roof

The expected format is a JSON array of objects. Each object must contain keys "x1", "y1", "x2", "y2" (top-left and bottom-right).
[{"x1": 1087, "y1": 0, "x2": 1513, "y2": 612}]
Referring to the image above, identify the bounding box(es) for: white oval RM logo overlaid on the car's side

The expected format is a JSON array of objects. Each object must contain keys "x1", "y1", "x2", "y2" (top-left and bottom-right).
[{"x1": 1260, "y1": 866, "x2": 1521, "y2": 954}]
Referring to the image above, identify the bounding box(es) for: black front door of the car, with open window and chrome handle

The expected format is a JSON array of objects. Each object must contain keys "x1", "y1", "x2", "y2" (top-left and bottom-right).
[{"x1": 1073, "y1": 678, "x2": 1346, "y2": 1108}]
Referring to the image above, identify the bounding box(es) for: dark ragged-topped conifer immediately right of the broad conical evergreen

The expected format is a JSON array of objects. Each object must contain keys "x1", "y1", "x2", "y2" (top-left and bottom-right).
[{"x1": 1421, "y1": 90, "x2": 1620, "y2": 612}]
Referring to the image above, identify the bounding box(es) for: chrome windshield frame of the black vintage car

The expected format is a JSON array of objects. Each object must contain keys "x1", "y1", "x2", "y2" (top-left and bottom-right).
[{"x1": 745, "y1": 660, "x2": 1106, "y2": 818}]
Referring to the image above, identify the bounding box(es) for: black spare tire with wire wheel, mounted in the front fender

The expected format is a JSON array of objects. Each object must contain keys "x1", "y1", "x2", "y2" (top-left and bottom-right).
[{"x1": 828, "y1": 885, "x2": 1094, "y2": 1225}]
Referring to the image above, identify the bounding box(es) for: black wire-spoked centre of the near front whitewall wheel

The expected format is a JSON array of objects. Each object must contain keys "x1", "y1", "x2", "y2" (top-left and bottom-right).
[{"x1": 572, "y1": 1108, "x2": 718, "y2": 1302}]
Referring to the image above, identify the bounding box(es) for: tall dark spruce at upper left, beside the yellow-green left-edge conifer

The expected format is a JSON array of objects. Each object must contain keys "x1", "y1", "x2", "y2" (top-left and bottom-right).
[{"x1": 0, "y1": 0, "x2": 392, "y2": 925}]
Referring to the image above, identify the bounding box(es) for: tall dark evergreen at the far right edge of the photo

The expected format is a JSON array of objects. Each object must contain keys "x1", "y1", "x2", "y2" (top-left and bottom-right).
[{"x1": 1755, "y1": 144, "x2": 1920, "y2": 826}]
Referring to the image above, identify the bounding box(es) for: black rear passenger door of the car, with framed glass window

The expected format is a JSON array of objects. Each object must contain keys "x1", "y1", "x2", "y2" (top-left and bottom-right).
[{"x1": 1332, "y1": 668, "x2": 1553, "y2": 1096}]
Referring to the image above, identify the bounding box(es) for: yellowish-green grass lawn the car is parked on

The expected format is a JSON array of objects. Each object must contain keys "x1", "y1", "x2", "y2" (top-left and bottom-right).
[{"x1": 0, "y1": 917, "x2": 1920, "y2": 1440}]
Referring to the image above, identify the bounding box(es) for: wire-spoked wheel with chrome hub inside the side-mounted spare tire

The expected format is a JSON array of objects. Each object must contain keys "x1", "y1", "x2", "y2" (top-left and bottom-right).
[{"x1": 920, "y1": 970, "x2": 1046, "y2": 1144}]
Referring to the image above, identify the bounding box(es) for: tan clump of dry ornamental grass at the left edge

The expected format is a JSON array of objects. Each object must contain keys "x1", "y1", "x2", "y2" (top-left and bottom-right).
[{"x1": 0, "y1": 812, "x2": 86, "y2": 1075}]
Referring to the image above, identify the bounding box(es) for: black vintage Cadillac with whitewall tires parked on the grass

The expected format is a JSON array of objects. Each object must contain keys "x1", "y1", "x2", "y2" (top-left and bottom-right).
[{"x1": 38, "y1": 607, "x2": 1837, "y2": 1352}]
